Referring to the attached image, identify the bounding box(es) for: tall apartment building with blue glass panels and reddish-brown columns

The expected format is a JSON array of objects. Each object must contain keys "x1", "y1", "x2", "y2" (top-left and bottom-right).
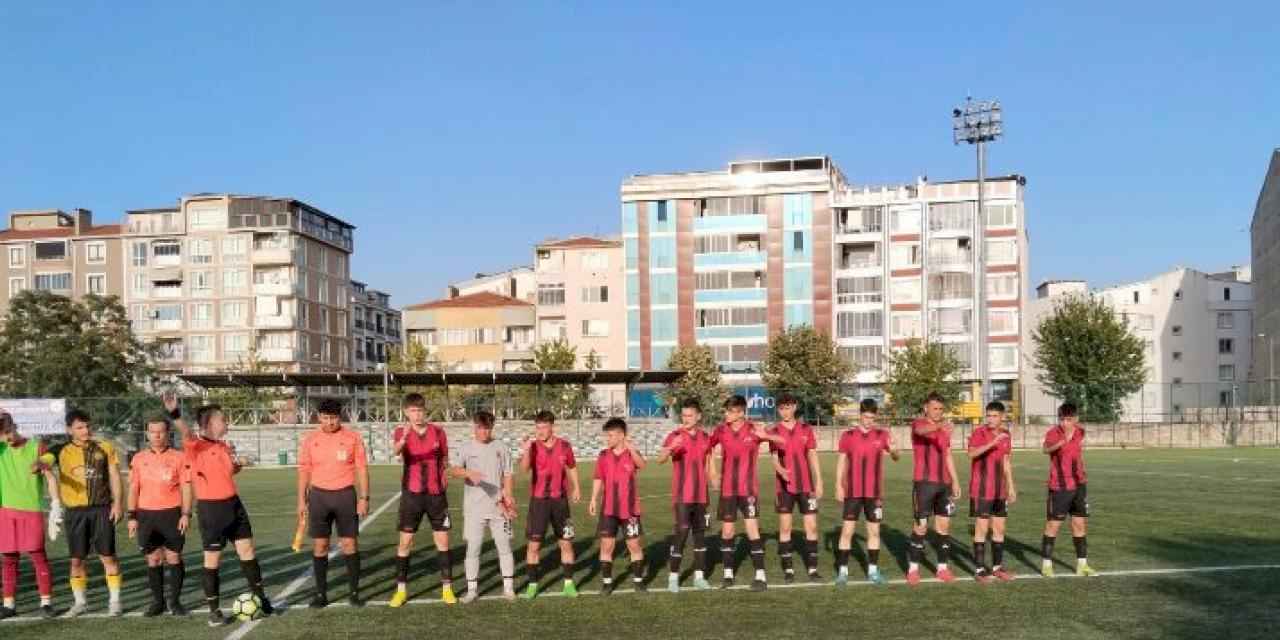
[{"x1": 621, "y1": 157, "x2": 844, "y2": 375}]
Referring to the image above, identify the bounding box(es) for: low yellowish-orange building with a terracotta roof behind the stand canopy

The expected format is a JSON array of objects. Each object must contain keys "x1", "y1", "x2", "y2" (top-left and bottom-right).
[{"x1": 403, "y1": 291, "x2": 536, "y2": 371}]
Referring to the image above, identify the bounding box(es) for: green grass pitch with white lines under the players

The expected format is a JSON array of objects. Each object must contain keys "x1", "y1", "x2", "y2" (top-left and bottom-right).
[{"x1": 0, "y1": 449, "x2": 1280, "y2": 640}]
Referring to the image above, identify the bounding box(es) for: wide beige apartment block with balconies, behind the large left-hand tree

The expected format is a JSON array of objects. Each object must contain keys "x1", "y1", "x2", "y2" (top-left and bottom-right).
[{"x1": 122, "y1": 193, "x2": 355, "y2": 372}]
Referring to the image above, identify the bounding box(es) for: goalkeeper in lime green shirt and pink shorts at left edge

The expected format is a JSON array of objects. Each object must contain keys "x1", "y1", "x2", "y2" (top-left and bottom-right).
[{"x1": 0, "y1": 412, "x2": 63, "y2": 620}]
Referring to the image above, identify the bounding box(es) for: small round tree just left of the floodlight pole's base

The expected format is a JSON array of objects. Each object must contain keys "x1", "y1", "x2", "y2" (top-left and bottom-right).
[{"x1": 884, "y1": 339, "x2": 964, "y2": 417}]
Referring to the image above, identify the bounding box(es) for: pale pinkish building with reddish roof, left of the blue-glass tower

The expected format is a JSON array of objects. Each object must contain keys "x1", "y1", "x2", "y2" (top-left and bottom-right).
[{"x1": 534, "y1": 237, "x2": 627, "y2": 369}]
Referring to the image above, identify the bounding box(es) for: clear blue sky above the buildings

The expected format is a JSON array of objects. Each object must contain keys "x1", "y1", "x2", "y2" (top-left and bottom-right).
[{"x1": 0, "y1": 1, "x2": 1280, "y2": 305}]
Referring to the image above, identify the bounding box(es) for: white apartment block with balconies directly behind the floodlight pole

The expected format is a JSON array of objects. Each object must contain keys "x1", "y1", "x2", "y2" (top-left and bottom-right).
[{"x1": 831, "y1": 175, "x2": 1028, "y2": 399}]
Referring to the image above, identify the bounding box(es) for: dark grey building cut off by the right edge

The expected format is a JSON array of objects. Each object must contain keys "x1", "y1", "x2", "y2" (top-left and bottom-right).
[{"x1": 1249, "y1": 148, "x2": 1280, "y2": 384}]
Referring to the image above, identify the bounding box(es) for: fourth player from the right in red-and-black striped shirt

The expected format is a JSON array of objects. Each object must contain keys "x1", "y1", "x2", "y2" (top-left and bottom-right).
[{"x1": 836, "y1": 398, "x2": 899, "y2": 586}]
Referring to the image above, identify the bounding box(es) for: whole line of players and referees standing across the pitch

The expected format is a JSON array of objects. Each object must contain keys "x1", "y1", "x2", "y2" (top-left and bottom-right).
[{"x1": 0, "y1": 394, "x2": 1094, "y2": 625}]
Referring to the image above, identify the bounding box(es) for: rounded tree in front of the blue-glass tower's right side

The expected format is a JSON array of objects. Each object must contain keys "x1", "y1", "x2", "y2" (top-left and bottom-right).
[{"x1": 760, "y1": 326, "x2": 854, "y2": 417}]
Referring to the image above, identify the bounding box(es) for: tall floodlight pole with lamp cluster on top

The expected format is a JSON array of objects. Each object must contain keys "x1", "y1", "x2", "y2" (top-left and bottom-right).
[{"x1": 951, "y1": 96, "x2": 1005, "y2": 399}]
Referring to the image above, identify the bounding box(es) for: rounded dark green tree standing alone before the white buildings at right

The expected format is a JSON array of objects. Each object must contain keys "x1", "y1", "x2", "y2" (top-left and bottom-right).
[{"x1": 1032, "y1": 296, "x2": 1147, "y2": 422}]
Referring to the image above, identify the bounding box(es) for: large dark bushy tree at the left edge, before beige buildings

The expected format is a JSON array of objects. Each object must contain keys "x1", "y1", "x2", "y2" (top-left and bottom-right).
[{"x1": 0, "y1": 291, "x2": 157, "y2": 398}]
